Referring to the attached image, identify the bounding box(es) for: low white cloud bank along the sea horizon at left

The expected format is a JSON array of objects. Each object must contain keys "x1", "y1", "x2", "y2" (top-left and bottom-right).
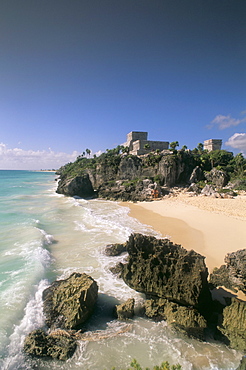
[{"x1": 0, "y1": 143, "x2": 79, "y2": 170}]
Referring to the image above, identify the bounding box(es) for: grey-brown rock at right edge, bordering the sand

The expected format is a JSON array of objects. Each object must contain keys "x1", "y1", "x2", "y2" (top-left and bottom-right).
[{"x1": 210, "y1": 249, "x2": 246, "y2": 294}]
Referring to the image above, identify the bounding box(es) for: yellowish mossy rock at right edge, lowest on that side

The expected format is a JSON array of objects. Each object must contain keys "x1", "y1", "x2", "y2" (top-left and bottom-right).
[{"x1": 218, "y1": 298, "x2": 246, "y2": 352}]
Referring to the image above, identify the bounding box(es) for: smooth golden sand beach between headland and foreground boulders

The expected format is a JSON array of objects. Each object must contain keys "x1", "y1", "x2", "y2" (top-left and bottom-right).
[{"x1": 123, "y1": 193, "x2": 246, "y2": 272}]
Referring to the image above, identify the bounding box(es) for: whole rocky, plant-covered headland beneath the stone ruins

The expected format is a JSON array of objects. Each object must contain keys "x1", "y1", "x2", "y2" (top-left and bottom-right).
[{"x1": 57, "y1": 148, "x2": 246, "y2": 201}]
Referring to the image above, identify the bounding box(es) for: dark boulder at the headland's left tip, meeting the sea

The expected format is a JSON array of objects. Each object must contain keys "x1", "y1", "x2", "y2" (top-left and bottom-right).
[{"x1": 56, "y1": 174, "x2": 95, "y2": 198}]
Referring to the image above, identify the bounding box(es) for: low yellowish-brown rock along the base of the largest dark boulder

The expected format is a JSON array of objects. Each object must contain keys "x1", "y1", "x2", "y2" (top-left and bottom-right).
[{"x1": 144, "y1": 298, "x2": 207, "y2": 340}]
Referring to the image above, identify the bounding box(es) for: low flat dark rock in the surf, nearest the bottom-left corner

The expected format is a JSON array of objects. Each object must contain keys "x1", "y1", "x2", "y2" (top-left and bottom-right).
[{"x1": 24, "y1": 329, "x2": 77, "y2": 361}]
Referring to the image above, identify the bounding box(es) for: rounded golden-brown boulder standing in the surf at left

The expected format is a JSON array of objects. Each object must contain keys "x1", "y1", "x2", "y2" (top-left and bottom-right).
[{"x1": 43, "y1": 273, "x2": 98, "y2": 329}]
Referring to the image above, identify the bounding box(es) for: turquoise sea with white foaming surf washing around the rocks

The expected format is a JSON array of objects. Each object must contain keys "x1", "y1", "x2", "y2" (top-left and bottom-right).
[{"x1": 0, "y1": 171, "x2": 242, "y2": 370}]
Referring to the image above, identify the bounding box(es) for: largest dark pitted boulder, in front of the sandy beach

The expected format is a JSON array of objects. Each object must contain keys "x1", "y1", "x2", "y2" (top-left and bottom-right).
[{"x1": 122, "y1": 234, "x2": 211, "y2": 312}]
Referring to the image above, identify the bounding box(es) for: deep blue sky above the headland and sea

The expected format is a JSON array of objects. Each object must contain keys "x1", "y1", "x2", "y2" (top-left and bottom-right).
[{"x1": 0, "y1": 0, "x2": 246, "y2": 169}]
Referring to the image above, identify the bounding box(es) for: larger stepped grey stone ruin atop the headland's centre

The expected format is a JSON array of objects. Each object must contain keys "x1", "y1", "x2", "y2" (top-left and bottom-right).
[{"x1": 124, "y1": 131, "x2": 169, "y2": 155}]
